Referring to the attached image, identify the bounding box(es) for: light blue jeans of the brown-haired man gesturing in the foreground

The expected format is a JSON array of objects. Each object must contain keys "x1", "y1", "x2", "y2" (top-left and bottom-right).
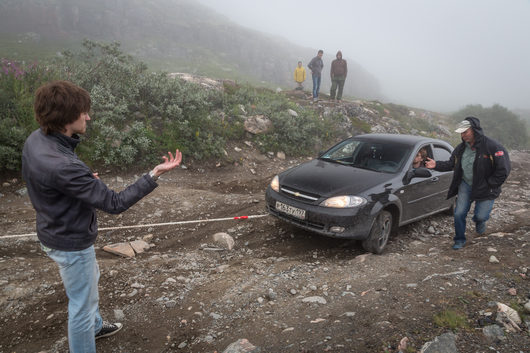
[{"x1": 46, "y1": 246, "x2": 103, "y2": 353}]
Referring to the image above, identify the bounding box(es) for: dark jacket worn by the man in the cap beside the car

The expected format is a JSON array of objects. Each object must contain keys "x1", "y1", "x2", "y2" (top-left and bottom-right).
[{"x1": 434, "y1": 117, "x2": 511, "y2": 201}]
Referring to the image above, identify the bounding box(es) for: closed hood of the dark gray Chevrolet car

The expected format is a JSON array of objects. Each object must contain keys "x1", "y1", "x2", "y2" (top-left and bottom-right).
[{"x1": 280, "y1": 159, "x2": 395, "y2": 197}]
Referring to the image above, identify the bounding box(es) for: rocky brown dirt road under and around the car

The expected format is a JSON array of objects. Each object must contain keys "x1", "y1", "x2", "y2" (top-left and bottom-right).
[{"x1": 0, "y1": 145, "x2": 530, "y2": 353}]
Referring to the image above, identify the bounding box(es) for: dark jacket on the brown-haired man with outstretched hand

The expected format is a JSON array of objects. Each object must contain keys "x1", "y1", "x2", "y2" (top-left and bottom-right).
[{"x1": 22, "y1": 129, "x2": 157, "y2": 251}]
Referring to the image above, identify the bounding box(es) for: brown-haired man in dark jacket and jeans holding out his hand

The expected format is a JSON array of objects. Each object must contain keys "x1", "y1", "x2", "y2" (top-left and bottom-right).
[{"x1": 22, "y1": 81, "x2": 182, "y2": 353}]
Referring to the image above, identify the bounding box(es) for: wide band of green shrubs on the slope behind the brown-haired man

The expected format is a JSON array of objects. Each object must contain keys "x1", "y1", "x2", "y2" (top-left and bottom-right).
[{"x1": 0, "y1": 40, "x2": 350, "y2": 170}]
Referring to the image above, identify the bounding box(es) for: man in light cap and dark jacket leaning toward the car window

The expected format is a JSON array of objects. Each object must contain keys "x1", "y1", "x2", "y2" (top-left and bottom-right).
[{"x1": 420, "y1": 116, "x2": 511, "y2": 250}]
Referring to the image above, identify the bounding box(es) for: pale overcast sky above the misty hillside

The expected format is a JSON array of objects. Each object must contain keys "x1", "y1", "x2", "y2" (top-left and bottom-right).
[{"x1": 196, "y1": 0, "x2": 530, "y2": 112}]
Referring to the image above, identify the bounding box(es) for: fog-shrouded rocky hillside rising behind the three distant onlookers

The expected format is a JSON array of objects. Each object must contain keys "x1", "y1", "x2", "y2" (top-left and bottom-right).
[{"x1": 0, "y1": 0, "x2": 383, "y2": 99}]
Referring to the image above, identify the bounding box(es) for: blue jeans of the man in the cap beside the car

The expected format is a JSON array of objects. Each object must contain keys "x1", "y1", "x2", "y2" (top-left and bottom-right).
[{"x1": 454, "y1": 181, "x2": 495, "y2": 242}]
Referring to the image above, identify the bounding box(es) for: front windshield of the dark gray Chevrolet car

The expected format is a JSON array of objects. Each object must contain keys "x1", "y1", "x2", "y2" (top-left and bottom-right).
[{"x1": 320, "y1": 140, "x2": 411, "y2": 173}]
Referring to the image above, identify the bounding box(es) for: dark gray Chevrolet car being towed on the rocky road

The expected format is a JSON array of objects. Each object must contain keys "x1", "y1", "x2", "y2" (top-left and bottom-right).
[{"x1": 265, "y1": 134, "x2": 453, "y2": 254}]
